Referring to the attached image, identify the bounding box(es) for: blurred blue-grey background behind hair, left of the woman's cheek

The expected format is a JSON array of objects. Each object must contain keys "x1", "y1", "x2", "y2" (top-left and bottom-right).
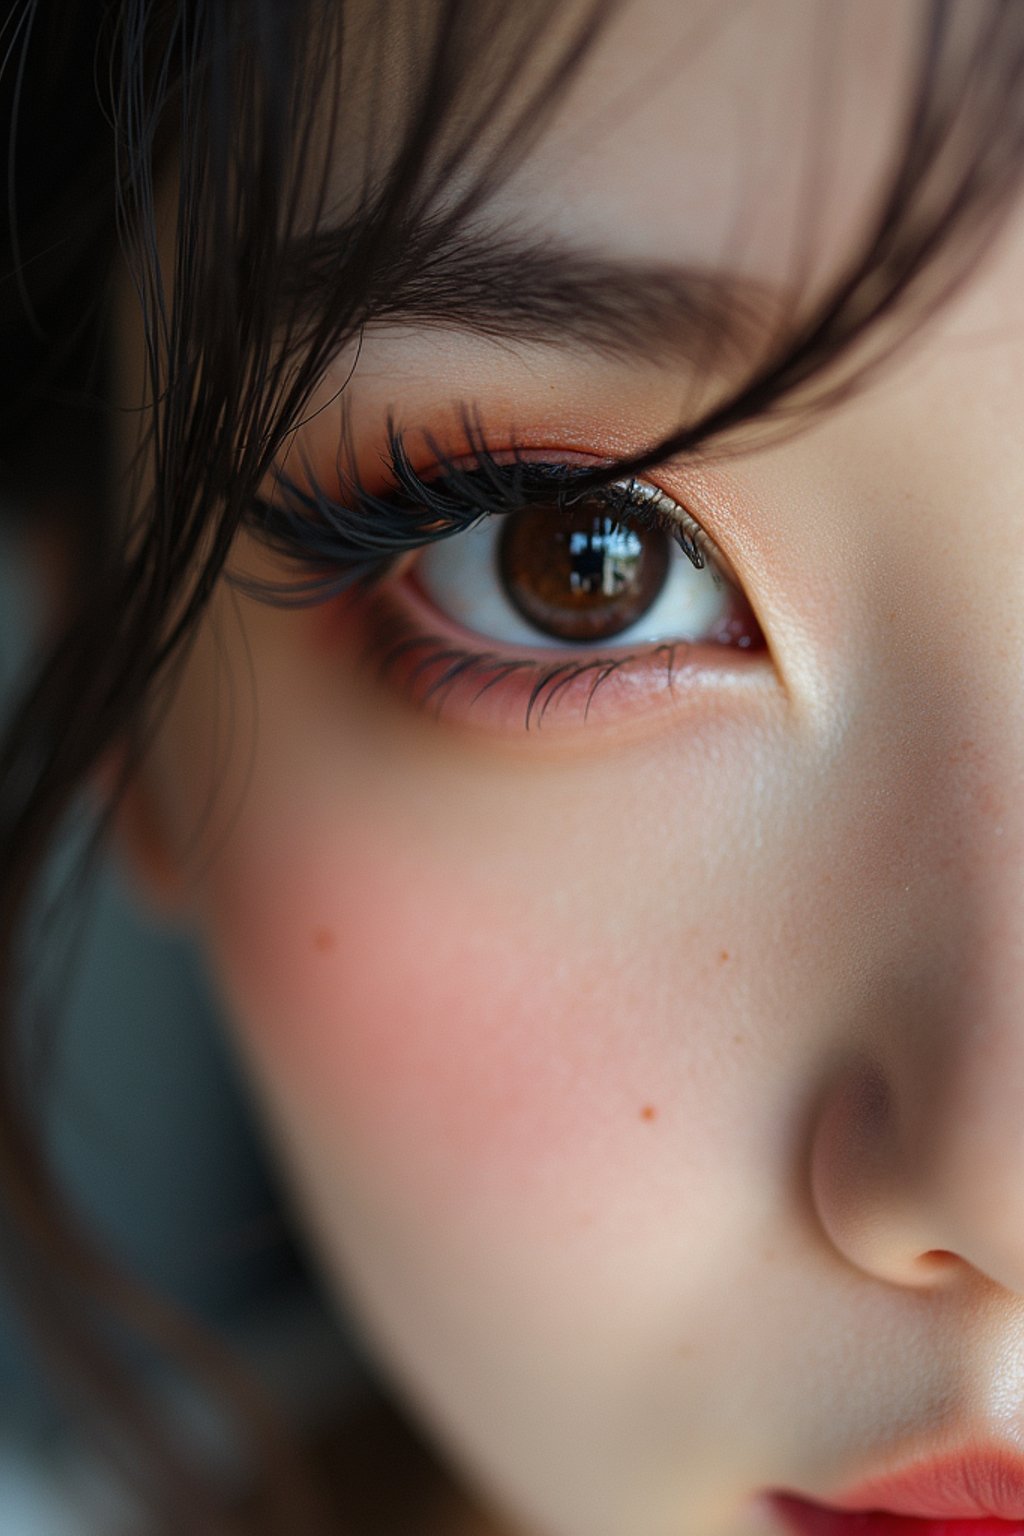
[{"x1": 0, "y1": 519, "x2": 366, "y2": 1536}]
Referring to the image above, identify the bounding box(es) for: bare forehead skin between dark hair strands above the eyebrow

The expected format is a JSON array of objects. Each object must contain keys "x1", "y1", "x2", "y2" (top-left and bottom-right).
[{"x1": 478, "y1": 0, "x2": 924, "y2": 281}]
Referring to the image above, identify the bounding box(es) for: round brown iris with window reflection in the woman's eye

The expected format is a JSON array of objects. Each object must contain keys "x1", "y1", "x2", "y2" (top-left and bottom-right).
[{"x1": 497, "y1": 498, "x2": 669, "y2": 642}]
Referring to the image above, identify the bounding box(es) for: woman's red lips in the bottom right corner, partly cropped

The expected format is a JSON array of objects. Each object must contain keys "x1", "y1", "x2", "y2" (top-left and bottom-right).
[{"x1": 771, "y1": 1450, "x2": 1024, "y2": 1536}]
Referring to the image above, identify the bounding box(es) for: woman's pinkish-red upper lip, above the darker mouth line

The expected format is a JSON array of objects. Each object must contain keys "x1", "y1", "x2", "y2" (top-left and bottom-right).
[{"x1": 801, "y1": 1445, "x2": 1024, "y2": 1521}]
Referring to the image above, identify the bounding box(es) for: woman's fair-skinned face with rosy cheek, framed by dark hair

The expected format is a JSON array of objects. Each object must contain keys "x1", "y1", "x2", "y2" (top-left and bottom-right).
[{"x1": 118, "y1": 0, "x2": 1024, "y2": 1536}]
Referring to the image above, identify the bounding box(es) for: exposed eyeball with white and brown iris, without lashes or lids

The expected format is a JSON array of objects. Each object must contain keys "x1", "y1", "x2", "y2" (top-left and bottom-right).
[{"x1": 411, "y1": 482, "x2": 757, "y2": 651}]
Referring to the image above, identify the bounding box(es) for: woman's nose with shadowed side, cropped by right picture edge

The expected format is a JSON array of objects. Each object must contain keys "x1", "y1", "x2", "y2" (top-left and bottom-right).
[{"x1": 809, "y1": 746, "x2": 1024, "y2": 1295}]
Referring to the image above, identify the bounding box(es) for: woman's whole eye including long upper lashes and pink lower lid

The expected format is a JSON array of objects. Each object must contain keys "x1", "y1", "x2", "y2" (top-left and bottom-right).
[{"x1": 233, "y1": 445, "x2": 775, "y2": 742}]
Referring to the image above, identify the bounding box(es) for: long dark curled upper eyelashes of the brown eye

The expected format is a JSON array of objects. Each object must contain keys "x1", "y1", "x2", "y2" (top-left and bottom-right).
[{"x1": 230, "y1": 422, "x2": 722, "y2": 607}]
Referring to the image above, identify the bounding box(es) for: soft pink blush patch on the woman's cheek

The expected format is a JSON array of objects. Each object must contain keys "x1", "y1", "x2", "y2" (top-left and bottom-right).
[{"x1": 207, "y1": 846, "x2": 672, "y2": 1234}]
